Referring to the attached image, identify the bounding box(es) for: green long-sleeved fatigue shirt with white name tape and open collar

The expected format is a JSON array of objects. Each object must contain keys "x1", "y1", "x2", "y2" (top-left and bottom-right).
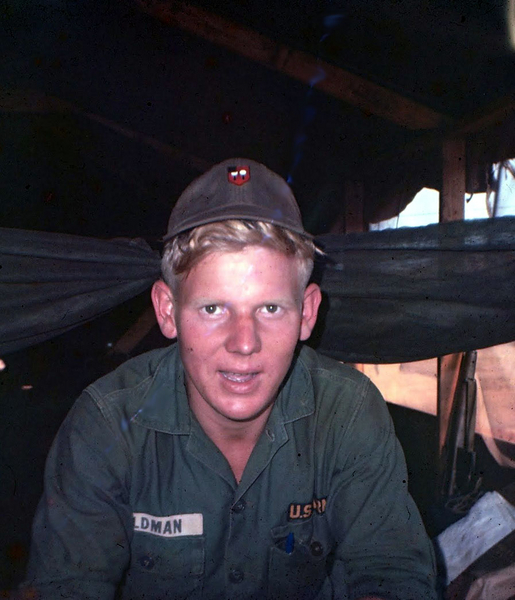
[{"x1": 26, "y1": 345, "x2": 436, "y2": 600}]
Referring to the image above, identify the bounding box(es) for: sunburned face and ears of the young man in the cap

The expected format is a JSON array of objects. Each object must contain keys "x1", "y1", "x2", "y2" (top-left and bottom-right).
[{"x1": 156, "y1": 246, "x2": 320, "y2": 425}]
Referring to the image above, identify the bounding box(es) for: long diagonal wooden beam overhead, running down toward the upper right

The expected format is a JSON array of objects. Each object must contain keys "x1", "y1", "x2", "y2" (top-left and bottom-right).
[{"x1": 135, "y1": 0, "x2": 448, "y2": 130}]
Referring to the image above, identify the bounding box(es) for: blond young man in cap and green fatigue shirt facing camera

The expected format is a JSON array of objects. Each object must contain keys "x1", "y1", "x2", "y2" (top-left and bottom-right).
[{"x1": 22, "y1": 159, "x2": 436, "y2": 600}]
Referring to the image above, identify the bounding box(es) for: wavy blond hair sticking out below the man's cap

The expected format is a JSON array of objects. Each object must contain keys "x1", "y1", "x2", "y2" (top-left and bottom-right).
[{"x1": 161, "y1": 219, "x2": 316, "y2": 293}]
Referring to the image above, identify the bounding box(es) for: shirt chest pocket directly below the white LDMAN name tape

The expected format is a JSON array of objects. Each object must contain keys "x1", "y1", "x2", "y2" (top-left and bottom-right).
[{"x1": 121, "y1": 532, "x2": 205, "y2": 600}]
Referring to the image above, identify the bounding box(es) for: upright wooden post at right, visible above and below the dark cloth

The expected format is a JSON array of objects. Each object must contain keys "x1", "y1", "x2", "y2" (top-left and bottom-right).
[{"x1": 437, "y1": 137, "x2": 466, "y2": 496}]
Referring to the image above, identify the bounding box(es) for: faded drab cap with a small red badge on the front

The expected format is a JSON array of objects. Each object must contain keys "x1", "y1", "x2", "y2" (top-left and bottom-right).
[{"x1": 163, "y1": 158, "x2": 312, "y2": 241}]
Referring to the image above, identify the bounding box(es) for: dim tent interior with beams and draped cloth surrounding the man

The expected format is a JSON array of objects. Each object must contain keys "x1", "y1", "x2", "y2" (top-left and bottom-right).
[{"x1": 0, "y1": 0, "x2": 515, "y2": 600}]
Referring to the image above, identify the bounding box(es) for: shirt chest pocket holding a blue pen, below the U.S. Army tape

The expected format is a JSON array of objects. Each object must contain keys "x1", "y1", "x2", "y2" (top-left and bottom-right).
[{"x1": 267, "y1": 515, "x2": 333, "y2": 600}]
